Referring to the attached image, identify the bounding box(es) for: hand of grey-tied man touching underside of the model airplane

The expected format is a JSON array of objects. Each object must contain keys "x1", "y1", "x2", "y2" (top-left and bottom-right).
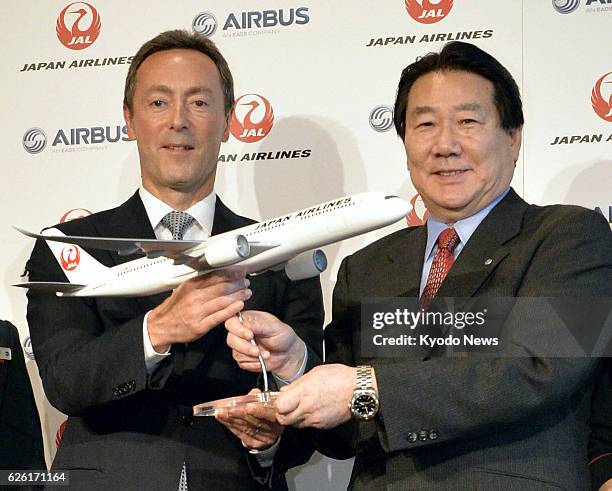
[{"x1": 147, "y1": 272, "x2": 251, "y2": 353}]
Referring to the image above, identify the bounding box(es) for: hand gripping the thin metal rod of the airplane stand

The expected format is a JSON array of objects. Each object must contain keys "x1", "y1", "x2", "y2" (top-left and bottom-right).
[{"x1": 225, "y1": 310, "x2": 305, "y2": 380}]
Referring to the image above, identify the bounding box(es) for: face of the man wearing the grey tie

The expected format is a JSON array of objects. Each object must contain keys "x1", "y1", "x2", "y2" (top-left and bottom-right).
[{"x1": 123, "y1": 49, "x2": 229, "y2": 202}]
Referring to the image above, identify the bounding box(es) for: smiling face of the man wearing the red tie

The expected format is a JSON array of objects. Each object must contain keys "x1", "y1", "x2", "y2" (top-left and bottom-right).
[{"x1": 404, "y1": 71, "x2": 521, "y2": 223}]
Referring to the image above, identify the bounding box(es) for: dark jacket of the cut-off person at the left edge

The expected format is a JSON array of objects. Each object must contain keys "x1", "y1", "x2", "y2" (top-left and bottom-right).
[{"x1": 0, "y1": 321, "x2": 47, "y2": 471}]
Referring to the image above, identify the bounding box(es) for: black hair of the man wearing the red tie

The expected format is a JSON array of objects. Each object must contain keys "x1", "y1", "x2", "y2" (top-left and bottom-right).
[{"x1": 393, "y1": 41, "x2": 524, "y2": 139}]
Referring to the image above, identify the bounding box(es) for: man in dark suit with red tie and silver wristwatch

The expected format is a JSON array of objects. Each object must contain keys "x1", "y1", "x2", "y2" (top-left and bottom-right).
[{"x1": 226, "y1": 42, "x2": 612, "y2": 491}]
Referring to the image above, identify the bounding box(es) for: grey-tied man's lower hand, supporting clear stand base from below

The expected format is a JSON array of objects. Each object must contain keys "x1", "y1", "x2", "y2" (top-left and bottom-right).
[{"x1": 215, "y1": 389, "x2": 284, "y2": 450}]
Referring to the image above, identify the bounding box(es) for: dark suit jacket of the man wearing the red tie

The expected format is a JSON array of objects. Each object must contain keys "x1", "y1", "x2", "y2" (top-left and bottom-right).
[{"x1": 316, "y1": 190, "x2": 612, "y2": 491}]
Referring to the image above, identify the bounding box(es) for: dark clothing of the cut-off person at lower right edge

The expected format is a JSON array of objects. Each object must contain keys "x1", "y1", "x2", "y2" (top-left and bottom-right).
[{"x1": 589, "y1": 359, "x2": 612, "y2": 490}]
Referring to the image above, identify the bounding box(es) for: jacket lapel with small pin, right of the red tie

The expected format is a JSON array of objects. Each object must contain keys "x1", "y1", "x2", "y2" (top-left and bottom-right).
[{"x1": 436, "y1": 189, "x2": 529, "y2": 308}]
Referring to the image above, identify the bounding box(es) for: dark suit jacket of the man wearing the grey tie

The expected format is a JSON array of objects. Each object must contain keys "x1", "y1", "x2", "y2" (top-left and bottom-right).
[{"x1": 27, "y1": 193, "x2": 323, "y2": 491}]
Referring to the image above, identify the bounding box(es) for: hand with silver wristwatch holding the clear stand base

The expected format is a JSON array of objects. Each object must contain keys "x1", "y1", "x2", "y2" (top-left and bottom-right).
[{"x1": 275, "y1": 364, "x2": 357, "y2": 429}]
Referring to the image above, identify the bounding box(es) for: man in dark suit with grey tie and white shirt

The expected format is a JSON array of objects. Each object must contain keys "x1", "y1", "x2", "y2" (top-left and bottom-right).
[{"x1": 27, "y1": 31, "x2": 323, "y2": 490}]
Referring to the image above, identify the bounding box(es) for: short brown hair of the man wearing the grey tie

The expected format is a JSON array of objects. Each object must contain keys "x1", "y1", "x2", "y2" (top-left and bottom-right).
[{"x1": 123, "y1": 29, "x2": 234, "y2": 116}]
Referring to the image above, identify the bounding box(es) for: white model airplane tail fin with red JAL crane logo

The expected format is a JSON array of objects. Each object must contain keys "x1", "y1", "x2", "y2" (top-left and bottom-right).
[{"x1": 42, "y1": 228, "x2": 110, "y2": 285}]
